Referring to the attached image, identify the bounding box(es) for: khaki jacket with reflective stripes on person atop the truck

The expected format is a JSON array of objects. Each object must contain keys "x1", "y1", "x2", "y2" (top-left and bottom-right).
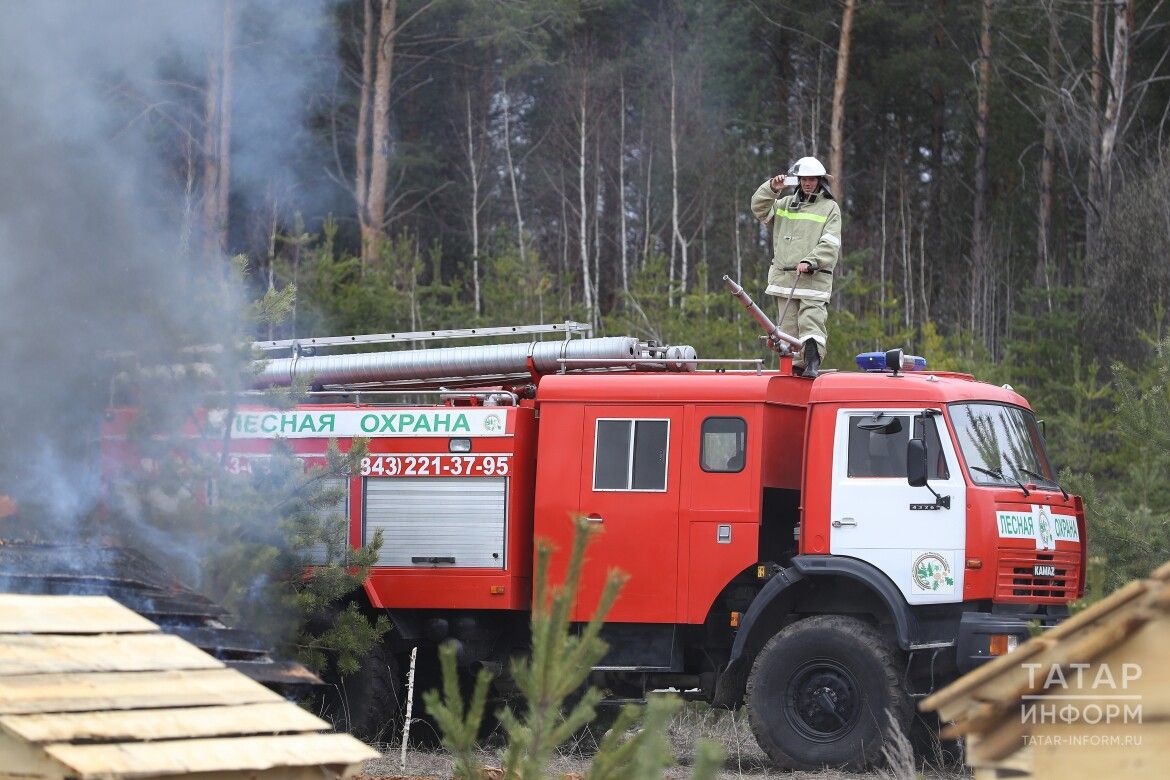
[{"x1": 751, "y1": 181, "x2": 841, "y2": 301}]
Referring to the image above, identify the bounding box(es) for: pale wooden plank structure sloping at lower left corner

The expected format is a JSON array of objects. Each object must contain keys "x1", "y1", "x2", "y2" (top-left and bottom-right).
[{"x1": 0, "y1": 594, "x2": 377, "y2": 780}]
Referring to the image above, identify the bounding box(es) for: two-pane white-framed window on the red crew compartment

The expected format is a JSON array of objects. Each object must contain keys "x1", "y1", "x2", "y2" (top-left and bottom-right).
[{"x1": 593, "y1": 420, "x2": 670, "y2": 490}]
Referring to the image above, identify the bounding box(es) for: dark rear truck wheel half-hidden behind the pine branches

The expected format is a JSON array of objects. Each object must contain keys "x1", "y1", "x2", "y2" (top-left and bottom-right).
[{"x1": 338, "y1": 642, "x2": 406, "y2": 743}]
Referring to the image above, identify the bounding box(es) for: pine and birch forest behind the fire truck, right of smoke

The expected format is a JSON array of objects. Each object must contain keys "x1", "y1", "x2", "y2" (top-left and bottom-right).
[{"x1": 217, "y1": 0, "x2": 1170, "y2": 593}]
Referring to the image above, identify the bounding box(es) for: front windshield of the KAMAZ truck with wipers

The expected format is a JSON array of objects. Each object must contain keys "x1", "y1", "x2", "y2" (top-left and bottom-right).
[{"x1": 950, "y1": 403, "x2": 1057, "y2": 485}]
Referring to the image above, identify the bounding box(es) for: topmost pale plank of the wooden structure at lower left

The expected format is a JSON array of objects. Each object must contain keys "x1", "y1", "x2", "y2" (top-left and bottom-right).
[{"x1": 0, "y1": 593, "x2": 158, "y2": 634}]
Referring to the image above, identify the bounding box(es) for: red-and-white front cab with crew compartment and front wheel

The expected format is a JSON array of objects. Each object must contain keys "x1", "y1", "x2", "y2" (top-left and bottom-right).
[{"x1": 535, "y1": 371, "x2": 1085, "y2": 767}]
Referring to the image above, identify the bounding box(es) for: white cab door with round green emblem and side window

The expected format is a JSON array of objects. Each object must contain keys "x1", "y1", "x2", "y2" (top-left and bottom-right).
[{"x1": 830, "y1": 409, "x2": 966, "y2": 603}]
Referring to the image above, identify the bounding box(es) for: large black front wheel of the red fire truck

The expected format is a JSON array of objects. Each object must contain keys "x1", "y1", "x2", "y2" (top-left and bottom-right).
[{"x1": 748, "y1": 615, "x2": 911, "y2": 772}]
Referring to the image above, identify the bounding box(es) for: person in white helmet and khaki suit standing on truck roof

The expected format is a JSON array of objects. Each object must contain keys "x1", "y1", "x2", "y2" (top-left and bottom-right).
[{"x1": 751, "y1": 157, "x2": 841, "y2": 377}]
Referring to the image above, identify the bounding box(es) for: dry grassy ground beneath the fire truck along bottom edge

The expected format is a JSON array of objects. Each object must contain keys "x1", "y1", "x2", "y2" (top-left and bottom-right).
[{"x1": 364, "y1": 709, "x2": 970, "y2": 780}]
